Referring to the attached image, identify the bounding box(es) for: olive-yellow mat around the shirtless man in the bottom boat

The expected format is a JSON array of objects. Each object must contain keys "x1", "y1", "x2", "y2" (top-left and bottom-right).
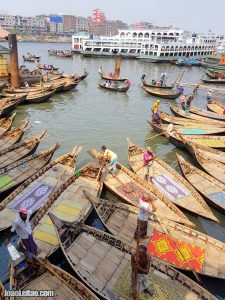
[{"x1": 112, "y1": 263, "x2": 188, "y2": 300}]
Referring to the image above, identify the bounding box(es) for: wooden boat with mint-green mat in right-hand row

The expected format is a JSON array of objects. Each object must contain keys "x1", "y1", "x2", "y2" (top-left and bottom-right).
[{"x1": 148, "y1": 121, "x2": 225, "y2": 135}]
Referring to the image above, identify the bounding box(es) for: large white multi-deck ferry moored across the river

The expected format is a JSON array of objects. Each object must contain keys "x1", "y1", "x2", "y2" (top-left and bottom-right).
[{"x1": 72, "y1": 28, "x2": 224, "y2": 62}]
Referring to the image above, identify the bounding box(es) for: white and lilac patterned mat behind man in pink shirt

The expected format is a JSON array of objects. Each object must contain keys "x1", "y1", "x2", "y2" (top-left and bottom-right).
[{"x1": 152, "y1": 174, "x2": 190, "y2": 201}]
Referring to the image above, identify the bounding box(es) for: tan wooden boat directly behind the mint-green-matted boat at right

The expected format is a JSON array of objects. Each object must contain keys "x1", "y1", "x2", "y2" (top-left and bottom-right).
[{"x1": 159, "y1": 111, "x2": 224, "y2": 127}]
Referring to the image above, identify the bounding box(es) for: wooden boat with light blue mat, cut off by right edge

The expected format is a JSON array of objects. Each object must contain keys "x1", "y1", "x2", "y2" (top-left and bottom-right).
[{"x1": 177, "y1": 154, "x2": 225, "y2": 213}]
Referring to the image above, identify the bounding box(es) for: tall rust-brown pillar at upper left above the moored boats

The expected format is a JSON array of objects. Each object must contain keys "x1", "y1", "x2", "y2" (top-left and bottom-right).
[{"x1": 8, "y1": 33, "x2": 20, "y2": 88}]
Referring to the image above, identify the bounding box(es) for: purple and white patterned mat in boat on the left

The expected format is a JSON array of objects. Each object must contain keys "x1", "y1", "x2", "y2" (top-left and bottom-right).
[{"x1": 8, "y1": 182, "x2": 53, "y2": 212}]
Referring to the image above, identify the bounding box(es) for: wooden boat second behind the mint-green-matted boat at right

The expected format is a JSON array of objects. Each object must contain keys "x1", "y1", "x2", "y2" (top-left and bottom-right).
[{"x1": 169, "y1": 104, "x2": 225, "y2": 127}]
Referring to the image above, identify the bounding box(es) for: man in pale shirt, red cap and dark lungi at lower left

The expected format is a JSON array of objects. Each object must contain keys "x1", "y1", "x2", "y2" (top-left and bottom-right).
[{"x1": 6, "y1": 208, "x2": 37, "y2": 256}]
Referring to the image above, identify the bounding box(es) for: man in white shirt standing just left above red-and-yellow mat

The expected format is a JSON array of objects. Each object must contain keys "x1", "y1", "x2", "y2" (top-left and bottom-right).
[{"x1": 134, "y1": 195, "x2": 156, "y2": 239}]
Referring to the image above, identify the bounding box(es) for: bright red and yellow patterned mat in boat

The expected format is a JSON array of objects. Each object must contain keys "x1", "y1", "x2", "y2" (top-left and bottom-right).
[{"x1": 147, "y1": 230, "x2": 205, "y2": 272}]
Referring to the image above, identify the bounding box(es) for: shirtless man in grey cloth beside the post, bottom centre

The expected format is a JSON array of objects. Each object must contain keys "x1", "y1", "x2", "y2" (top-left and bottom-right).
[{"x1": 131, "y1": 245, "x2": 154, "y2": 296}]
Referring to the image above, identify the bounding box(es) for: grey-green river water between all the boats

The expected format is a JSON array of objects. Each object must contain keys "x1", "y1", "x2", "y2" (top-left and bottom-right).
[{"x1": 0, "y1": 43, "x2": 225, "y2": 299}]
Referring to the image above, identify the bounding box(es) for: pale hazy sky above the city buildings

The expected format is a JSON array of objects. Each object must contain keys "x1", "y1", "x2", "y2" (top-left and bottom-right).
[{"x1": 0, "y1": 0, "x2": 225, "y2": 33}]
